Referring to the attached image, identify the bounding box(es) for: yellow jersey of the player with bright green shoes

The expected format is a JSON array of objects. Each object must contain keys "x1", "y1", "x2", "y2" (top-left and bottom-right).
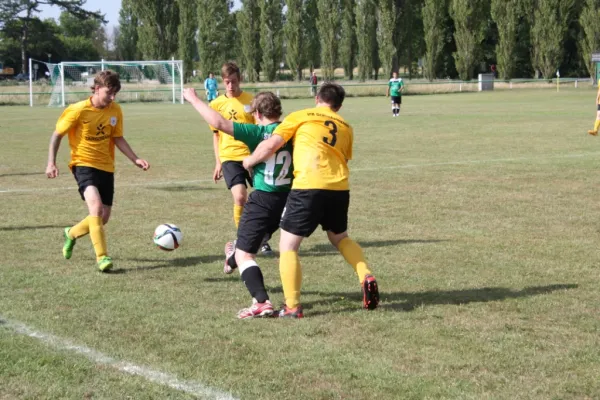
[{"x1": 56, "y1": 97, "x2": 123, "y2": 172}]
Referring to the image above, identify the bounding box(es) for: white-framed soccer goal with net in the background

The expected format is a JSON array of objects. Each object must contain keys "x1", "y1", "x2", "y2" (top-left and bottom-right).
[{"x1": 29, "y1": 59, "x2": 183, "y2": 107}]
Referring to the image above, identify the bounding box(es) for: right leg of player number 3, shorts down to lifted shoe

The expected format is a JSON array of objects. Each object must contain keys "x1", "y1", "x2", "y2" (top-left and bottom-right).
[{"x1": 321, "y1": 190, "x2": 379, "y2": 310}]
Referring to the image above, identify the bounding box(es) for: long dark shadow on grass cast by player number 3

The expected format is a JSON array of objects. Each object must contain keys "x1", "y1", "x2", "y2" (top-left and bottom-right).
[{"x1": 269, "y1": 283, "x2": 579, "y2": 315}]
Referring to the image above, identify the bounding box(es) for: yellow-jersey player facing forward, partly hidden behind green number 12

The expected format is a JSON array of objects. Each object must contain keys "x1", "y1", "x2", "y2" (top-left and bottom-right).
[{"x1": 210, "y1": 62, "x2": 272, "y2": 254}]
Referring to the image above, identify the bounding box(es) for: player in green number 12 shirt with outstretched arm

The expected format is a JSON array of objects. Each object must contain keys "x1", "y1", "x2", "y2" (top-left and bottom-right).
[{"x1": 183, "y1": 88, "x2": 294, "y2": 319}]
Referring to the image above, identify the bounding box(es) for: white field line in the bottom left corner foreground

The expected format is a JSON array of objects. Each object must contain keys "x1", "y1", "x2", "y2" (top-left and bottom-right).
[{"x1": 0, "y1": 316, "x2": 236, "y2": 400}]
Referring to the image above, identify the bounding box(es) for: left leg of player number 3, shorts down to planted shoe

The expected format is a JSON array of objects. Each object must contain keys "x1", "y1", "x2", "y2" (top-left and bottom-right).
[{"x1": 279, "y1": 190, "x2": 323, "y2": 318}]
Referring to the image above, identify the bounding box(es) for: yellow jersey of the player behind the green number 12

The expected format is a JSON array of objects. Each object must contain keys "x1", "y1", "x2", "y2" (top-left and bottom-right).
[{"x1": 210, "y1": 92, "x2": 255, "y2": 162}]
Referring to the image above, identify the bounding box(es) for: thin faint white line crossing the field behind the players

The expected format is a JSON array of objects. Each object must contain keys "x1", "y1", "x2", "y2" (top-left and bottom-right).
[{"x1": 0, "y1": 151, "x2": 600, "y2": 194}]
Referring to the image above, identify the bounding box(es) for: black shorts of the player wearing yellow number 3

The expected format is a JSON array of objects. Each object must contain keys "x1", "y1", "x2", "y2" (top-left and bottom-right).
[{"x1": 280, "y1": 189, "x2": 350, "y2": 237}]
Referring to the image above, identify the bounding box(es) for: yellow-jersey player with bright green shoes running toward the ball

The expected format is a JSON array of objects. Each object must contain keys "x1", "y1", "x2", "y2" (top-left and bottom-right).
[{"x1": 46, "y1": 70, "x2": 150, "y2": 272}]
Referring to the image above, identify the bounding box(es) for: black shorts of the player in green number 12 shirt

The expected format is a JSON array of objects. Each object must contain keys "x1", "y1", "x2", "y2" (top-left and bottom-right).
[{"x1": 235, "y1": 190, "x2": 289, "y2": 254}]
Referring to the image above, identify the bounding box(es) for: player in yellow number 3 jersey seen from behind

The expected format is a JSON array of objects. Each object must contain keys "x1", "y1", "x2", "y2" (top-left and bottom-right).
[{"x1": 244, "y1": 83, "x2": 379, "y2": 318}]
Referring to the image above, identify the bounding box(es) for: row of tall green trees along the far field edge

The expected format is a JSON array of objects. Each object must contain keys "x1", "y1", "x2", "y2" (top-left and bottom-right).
[{"x1": 0, "y1": 0, "x2": 600, "y2": 82}]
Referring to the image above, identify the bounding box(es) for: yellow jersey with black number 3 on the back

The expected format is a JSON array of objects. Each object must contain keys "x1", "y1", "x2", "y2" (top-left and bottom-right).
[{"x1": 273, "y1": 107, "x2": 354, "y2": 190}]
